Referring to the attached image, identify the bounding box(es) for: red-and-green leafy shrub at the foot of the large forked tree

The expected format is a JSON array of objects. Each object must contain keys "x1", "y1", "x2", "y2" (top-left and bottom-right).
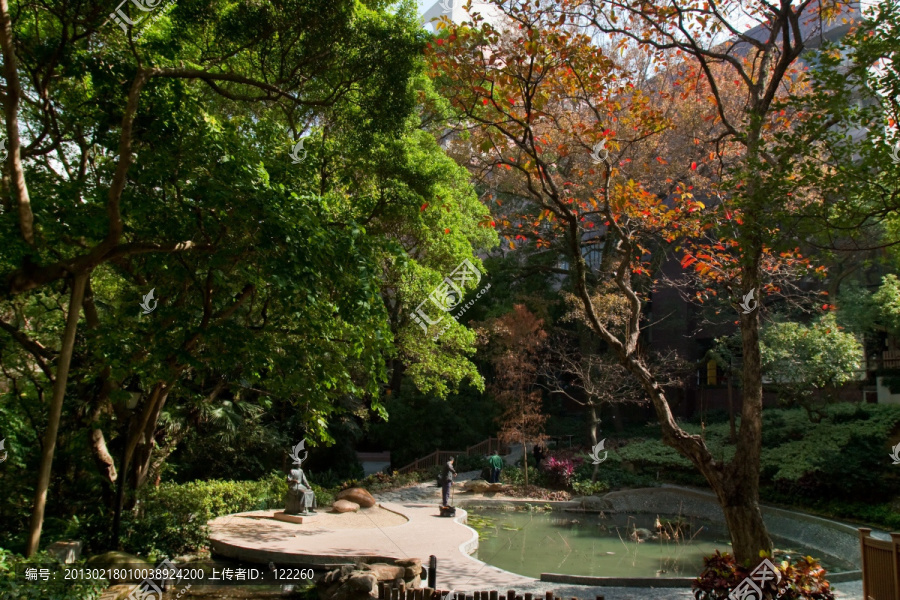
[{"x1": 691, "y1": 550, "x2": 834, "y2": 600}]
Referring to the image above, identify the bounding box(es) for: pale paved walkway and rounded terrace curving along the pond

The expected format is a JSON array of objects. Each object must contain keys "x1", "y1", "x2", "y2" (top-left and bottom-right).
[{"x1": 210, "y1": 471, "x2": 863, "y2": 600}]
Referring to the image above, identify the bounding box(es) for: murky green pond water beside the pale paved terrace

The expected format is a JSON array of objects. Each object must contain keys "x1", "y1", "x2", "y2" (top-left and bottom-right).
[{"x1": 469, "y1": 509, "x2": 852, "y2": 578}]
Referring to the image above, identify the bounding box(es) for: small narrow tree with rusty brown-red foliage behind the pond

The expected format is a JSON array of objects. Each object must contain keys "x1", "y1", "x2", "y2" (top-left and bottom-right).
[{"x1": 487, "y1": 304, "x2": 547, "y2": 487}]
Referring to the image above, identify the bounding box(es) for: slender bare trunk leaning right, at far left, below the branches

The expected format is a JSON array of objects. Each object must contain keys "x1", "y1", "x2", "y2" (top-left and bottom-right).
[{"x1": 25, "y1": 273, "x2": 88, "y2": 556}]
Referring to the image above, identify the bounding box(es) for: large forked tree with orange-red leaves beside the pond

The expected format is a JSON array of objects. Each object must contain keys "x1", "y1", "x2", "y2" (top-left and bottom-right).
[{"x1": 429, "y1": 0, "x2": 852, "y2": 561}]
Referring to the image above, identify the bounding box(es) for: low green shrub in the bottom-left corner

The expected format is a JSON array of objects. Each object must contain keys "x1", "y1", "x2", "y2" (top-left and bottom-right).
[{"x1": 0, "y1": 548, "x2": 109, "y2": 600}]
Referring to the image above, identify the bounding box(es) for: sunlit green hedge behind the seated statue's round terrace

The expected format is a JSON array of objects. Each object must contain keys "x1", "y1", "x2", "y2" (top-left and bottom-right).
[{"x1": 123, "y1": 473, "x2": 287, "y2": 556}]
